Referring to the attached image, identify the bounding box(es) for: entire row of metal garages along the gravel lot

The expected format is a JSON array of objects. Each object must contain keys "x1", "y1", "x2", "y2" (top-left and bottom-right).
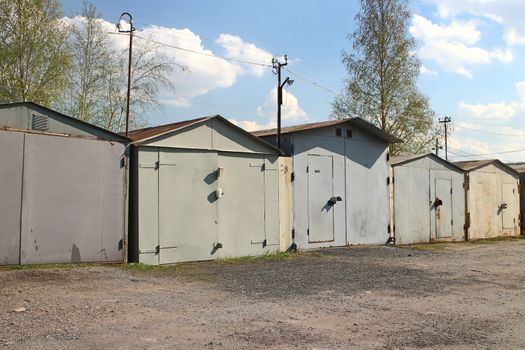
[{"x1": 0, "y1": 103, "x2": 519, "y2": 264}]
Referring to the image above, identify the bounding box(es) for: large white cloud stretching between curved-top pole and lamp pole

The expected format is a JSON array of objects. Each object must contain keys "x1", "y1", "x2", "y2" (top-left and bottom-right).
[{"x1": 67, "y1": 16, "x2": 272, "y2": 107}]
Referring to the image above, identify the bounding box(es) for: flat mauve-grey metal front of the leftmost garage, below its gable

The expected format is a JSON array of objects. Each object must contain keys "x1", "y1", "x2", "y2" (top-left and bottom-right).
[{"x1": 0, "y1": 132, "x2": 125, "y2": 264}]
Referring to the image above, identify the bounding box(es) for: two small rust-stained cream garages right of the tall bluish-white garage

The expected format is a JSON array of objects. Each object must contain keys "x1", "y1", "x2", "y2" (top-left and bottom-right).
[{"x1": 390, "y1": 154, "x2": 520, "y2": 244}]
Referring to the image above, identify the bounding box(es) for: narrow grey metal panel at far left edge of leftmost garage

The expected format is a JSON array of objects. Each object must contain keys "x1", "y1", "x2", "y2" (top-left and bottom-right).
[{"x1": 0, "y1": 131, "x2": 24, "y2": 265}]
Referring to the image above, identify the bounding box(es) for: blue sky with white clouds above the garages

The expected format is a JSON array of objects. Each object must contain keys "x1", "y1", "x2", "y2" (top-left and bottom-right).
[{"x1": 62, "y1": 0, "x2": 525, "y2": 162}]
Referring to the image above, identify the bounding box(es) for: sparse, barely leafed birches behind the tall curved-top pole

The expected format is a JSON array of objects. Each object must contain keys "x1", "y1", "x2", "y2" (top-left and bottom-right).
[{"x1": 60, "y1": 2, "x2": 175, "y2": 132}]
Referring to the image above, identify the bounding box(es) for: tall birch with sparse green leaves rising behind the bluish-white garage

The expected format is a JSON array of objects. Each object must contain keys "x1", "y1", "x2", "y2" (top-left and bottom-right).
[{"x1": 332, "y1": 0, "x2": 437, "y2": 154}]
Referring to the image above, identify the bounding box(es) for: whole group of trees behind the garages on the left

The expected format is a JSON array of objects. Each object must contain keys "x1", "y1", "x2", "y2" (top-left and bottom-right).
[{"x1": 0, "y1": 0, "x2": 178, "y2": 132}]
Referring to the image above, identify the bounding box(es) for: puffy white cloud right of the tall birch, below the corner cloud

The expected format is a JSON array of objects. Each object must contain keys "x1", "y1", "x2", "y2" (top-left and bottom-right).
[{"x1": 410, "y1": 15, "x2": 513, "y2": 78}]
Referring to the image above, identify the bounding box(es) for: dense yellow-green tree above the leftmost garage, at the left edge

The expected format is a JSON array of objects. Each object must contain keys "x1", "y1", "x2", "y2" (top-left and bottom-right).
[{"x1": 0, "y1": 0, "x2": 71, "y2": 106}]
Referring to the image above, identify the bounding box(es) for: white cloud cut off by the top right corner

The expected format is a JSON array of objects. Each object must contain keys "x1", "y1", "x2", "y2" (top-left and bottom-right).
[{"x1": 434, "y1": 0, "x2": 525, "y2": 45}]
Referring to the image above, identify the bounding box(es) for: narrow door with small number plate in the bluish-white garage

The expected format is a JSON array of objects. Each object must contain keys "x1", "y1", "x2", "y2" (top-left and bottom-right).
[{"x1": 308, "y1": 155, "x2": 334, "y2": 243}]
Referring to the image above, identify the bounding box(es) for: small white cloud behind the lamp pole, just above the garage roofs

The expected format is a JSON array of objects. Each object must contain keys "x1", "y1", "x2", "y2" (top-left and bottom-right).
[{"x1": 257, "y1": 87, "x2": 307, "y2": 121}]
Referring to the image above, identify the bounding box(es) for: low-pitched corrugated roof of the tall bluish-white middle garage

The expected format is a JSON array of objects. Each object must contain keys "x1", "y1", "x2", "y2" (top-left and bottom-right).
[{"x1": 252, "y1": 117, "x2": 401, "y2": 143}]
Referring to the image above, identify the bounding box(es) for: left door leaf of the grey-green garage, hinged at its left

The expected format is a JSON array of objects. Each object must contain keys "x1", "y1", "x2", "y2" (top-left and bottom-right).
[{"x1": 159, "y1": 149, "x2": 218, "y2": 264}]
